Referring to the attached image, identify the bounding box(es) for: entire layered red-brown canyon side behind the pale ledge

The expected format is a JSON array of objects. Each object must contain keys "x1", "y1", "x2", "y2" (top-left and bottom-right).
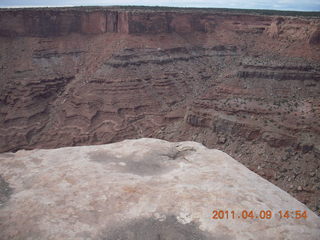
[{"x1": 0, "y1": 7, "x2": 320, "y2": 214}]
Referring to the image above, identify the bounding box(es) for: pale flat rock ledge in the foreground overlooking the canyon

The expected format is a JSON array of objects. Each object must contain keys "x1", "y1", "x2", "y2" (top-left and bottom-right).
[{"x1": 0, "y1": 139, "x2": 320, "y2": 240}]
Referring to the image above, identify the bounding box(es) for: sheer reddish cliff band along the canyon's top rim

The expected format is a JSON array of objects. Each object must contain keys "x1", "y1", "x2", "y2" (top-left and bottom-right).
[{"x1": 0, "y1": 8, "x2": 319, "y2": 36}]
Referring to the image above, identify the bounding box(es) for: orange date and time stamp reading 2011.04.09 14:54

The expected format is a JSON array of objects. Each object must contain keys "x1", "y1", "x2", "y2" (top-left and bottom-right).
[{"x1": 211, "y1": 209, "x2": 308, "y2": 220}]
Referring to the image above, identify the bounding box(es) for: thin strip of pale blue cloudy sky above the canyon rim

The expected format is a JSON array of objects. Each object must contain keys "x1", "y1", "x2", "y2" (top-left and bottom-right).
[{"x1": 0, "y1": 0, "x2": 320, "y2": 11}]
